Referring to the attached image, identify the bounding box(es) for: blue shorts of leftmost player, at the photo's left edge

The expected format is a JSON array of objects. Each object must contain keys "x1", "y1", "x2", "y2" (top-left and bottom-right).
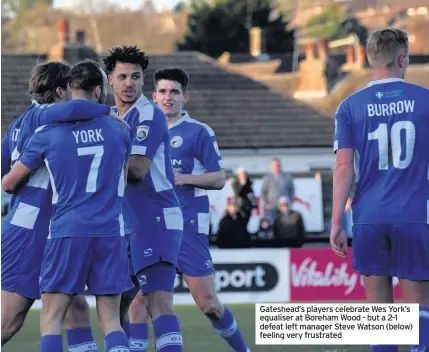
[{"x1": 1, "y1": 221, "x2": 48, "y2": 299}]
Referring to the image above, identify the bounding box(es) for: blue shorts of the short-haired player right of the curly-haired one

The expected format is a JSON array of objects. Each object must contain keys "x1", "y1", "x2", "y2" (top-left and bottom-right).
[{"x1": 177, "y1": 232, "x2": 214, "y2": 277}]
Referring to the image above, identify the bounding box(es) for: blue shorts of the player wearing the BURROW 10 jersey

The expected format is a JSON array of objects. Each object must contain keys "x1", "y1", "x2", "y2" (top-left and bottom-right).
[{"x1": 353, "y1": 224, "x2": 429, "y2": 281}]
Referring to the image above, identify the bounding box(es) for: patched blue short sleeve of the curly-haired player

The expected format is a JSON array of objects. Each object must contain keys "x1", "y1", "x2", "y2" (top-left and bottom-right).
[{"x1": 131, "y1": 107, "x2": 168, "y2": 160}]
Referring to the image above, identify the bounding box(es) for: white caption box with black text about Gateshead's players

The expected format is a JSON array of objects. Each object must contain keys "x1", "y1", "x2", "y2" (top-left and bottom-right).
[{"x1": 255, "y1": 303, "x2": 419, "y2": 345}]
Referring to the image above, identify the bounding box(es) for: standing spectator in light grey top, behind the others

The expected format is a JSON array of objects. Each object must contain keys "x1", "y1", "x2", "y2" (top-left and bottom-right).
[{"x1": 261, "y1": 158, "x2": 295, "y2": 223}]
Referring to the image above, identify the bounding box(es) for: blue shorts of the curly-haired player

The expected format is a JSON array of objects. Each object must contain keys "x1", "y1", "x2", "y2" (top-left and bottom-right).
[{"x1": 130, "y1": 230, "x2": 183, "y2": 273}]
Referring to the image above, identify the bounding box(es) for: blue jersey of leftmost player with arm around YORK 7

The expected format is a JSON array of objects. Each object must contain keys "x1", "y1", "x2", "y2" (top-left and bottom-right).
[{"x1": 2, "y1": 100, "x2": 110, "y2": 232}]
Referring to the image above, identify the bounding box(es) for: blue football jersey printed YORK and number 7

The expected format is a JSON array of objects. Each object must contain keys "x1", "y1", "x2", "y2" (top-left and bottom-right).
[{"x1": 20, "y1": 117, "x2": 130, "y2": 238}]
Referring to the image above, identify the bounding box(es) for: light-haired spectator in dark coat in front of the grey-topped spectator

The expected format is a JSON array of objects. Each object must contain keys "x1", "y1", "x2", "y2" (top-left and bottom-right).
[{"x1": 273, "y1": 196, "x2": 305, "y2": 246}]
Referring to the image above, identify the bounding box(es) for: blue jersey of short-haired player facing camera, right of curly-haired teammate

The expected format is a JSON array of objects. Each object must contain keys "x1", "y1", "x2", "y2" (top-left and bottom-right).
[{"x1": 169, "y1": 112, "x2": 223, "y2": 235}]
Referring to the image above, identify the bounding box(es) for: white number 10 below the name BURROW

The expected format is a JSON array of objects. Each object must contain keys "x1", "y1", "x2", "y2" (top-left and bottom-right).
[{"x1": 368, "y1": 121, "x2": 416, "y2": 170}]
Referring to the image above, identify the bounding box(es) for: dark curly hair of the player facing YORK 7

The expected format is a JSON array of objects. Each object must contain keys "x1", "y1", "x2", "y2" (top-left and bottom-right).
[{"x1": 103, "y1": 45, "x2": 150, "y2": 73}]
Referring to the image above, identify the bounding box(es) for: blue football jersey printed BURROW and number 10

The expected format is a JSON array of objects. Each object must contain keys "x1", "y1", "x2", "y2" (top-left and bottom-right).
[{"x1": 334, "y1": 79, "x2": 429, "y2": 224}]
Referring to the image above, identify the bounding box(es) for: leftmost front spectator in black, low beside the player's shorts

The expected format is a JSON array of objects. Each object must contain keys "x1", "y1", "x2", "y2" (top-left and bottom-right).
[{"x1": 216, "y1": 202, "x2": 250, "y2": 248}]
